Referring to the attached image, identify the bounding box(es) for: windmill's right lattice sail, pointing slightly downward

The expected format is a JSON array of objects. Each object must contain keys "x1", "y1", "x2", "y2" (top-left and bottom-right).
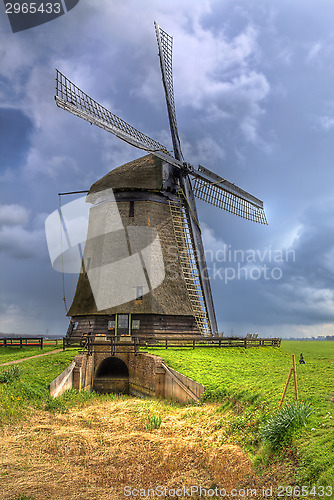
[{"x1": 193, "y1": 178, "x2": 268, "y2": 224}]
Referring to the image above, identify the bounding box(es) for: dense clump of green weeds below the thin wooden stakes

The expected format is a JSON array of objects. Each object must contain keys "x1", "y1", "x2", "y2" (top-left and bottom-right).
[{"x1": 261, "y1": 401, "x2": 314, "y2": 449}]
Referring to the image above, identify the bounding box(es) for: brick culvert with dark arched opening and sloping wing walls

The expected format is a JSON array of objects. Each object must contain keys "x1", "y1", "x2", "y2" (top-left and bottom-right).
[{"x1": 50, "y1": 342, "x2": 205, "y2": 403}]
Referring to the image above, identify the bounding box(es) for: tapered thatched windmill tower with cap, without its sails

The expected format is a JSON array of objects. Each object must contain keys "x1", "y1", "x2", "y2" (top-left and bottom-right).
[{"x1": 68, "y1": 155, "x2": 204, "y2": 337}]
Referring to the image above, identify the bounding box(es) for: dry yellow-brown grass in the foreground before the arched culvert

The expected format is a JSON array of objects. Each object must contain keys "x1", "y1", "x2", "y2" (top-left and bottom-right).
[{"x1": 0, "y1": 398, "x2": 290, "y2": 500}]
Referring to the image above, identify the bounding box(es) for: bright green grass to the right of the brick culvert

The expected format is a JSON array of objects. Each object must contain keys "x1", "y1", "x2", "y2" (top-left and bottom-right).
[{"x1": 149, "y1": 341, "x2": 334, "y2": 485}]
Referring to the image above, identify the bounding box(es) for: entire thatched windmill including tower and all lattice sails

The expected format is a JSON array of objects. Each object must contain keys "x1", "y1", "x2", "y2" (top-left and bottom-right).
[{"x1": 55, "y1": 24, "x2": 267, "y2": 336}]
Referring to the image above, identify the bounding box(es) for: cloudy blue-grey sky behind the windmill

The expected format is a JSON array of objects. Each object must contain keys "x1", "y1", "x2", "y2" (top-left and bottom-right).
[{"x1": 0, "y1": 0, "x2": 334, "y2": 338}]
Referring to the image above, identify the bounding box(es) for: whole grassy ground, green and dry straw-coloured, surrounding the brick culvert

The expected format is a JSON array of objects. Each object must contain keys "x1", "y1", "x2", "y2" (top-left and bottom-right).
[{"x1": 0, "y1": 341, "x2": 334, "y2": 500}]
